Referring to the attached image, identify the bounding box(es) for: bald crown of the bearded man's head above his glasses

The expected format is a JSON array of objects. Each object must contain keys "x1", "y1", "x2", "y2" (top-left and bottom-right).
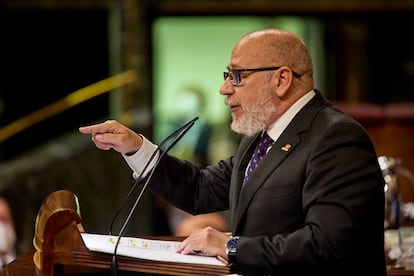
[{"x1": 233, "y1": 29, "x2": 313, "y2": 78}]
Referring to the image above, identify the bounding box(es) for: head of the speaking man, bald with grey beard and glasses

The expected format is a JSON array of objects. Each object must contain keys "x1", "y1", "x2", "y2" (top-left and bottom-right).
[{"x1": 220, "y1": 29, "x2": 314, "y2": 136}]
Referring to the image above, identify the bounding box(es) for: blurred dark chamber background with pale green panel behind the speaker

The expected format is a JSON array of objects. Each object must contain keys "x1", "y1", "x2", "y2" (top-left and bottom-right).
[{"x1": 0, "y1": 0, "x2": 414, "y2": 253}]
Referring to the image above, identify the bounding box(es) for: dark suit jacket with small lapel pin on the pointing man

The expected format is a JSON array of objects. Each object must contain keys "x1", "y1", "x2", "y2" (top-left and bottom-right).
[{"x1": 150, "y1": 91, "x2": 386, "y2": 276}]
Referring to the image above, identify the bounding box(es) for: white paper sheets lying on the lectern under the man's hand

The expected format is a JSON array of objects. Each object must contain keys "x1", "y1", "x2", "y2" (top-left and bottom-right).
[{"x1": 81, "y1": 233, "x2": 225, "y2": 266}]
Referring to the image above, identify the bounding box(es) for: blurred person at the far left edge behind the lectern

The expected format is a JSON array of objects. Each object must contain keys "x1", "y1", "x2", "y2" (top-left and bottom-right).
[{"x1": 0, "y1": 198, "x2": 16, "y2": 270}]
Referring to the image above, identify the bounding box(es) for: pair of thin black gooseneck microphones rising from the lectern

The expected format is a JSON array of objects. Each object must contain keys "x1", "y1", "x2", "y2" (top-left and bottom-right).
[{"x1": 109, "y1": 117, "x2": 198, "y2": 276}]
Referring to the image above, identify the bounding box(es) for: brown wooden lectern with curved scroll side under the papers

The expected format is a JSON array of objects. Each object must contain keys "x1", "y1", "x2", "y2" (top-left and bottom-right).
[{"x1": 29, "y1": 190, "x2": 229, "y2": 276}]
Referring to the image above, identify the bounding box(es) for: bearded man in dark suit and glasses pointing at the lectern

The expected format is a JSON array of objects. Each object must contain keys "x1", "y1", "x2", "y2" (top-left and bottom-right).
[{"x1": 80, "y1": 29, "x2": 386, "y2": 275}]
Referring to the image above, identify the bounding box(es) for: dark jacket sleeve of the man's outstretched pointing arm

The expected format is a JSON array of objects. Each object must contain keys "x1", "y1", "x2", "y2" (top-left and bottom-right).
[{"x1": 150, "y1": 155, "x2": 232, "y2": 214}]
